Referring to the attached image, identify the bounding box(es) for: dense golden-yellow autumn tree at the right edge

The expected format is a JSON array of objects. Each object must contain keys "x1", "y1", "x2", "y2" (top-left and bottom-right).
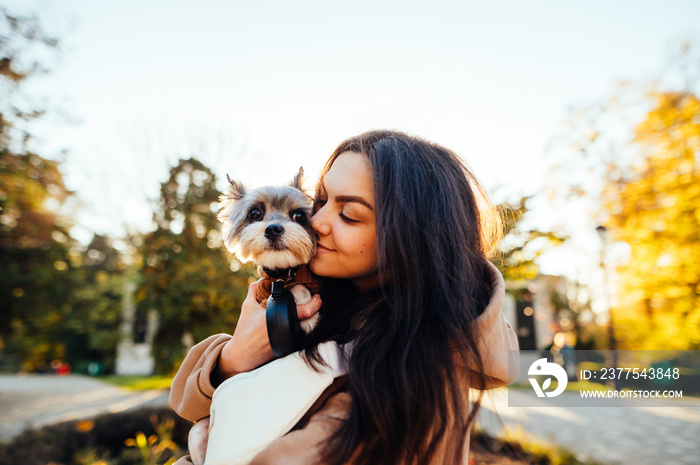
[{"x1": 605, "y1": 92, "x2": 700, "y2": 349}]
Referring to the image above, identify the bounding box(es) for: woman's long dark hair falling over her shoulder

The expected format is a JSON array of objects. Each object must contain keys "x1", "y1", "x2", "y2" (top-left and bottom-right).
[{"x1": 306, "y1": 131, "x2": 498, "y2": 464}]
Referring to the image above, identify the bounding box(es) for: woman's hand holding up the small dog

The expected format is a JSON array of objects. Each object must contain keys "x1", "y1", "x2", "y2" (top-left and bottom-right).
[{"x1": 218, "y1": 282, "x2": 321, "y2": 380}]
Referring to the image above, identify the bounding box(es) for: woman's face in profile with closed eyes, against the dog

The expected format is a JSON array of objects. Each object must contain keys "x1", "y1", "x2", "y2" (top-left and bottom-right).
[{"x1": 310, "y1": 152, "x2": 378, "y2": 289}]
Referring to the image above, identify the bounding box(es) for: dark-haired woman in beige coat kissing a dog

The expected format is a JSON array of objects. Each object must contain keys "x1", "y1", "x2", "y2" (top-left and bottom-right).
[{"x1": 171, "y1": 131, "x2": 518, "y2": 464}]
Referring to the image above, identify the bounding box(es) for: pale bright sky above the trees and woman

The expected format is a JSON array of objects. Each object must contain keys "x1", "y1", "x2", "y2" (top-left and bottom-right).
[{"x1": 9, "y1": 0, "x2": 700, "y2": 282}]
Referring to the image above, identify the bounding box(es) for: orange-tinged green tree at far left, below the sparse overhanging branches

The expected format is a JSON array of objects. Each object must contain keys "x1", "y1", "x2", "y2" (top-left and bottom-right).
[{"x1": 0, "y1": 148, "x2": 74, "y2": 370}]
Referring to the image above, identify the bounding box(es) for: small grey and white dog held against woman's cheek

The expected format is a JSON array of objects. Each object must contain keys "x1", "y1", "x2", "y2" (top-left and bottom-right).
[{"x1": 188, "y1": 168, "x2": 320, "y2": 465}]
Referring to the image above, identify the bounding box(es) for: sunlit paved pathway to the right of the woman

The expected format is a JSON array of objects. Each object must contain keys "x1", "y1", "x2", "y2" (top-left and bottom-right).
[{"x1": 477, "y1": 388, "x2": 700, "y2": 465}]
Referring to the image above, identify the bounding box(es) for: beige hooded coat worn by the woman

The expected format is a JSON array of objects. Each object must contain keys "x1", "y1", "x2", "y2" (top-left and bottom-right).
[{"x1": 170, "y1": 266, "x2": 518, "y2": 465}]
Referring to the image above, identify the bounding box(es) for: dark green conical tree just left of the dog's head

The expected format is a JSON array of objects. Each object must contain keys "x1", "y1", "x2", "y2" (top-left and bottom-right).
[{"x1": 136, "y1": 158, "x2": 254, "y2": 372}]
